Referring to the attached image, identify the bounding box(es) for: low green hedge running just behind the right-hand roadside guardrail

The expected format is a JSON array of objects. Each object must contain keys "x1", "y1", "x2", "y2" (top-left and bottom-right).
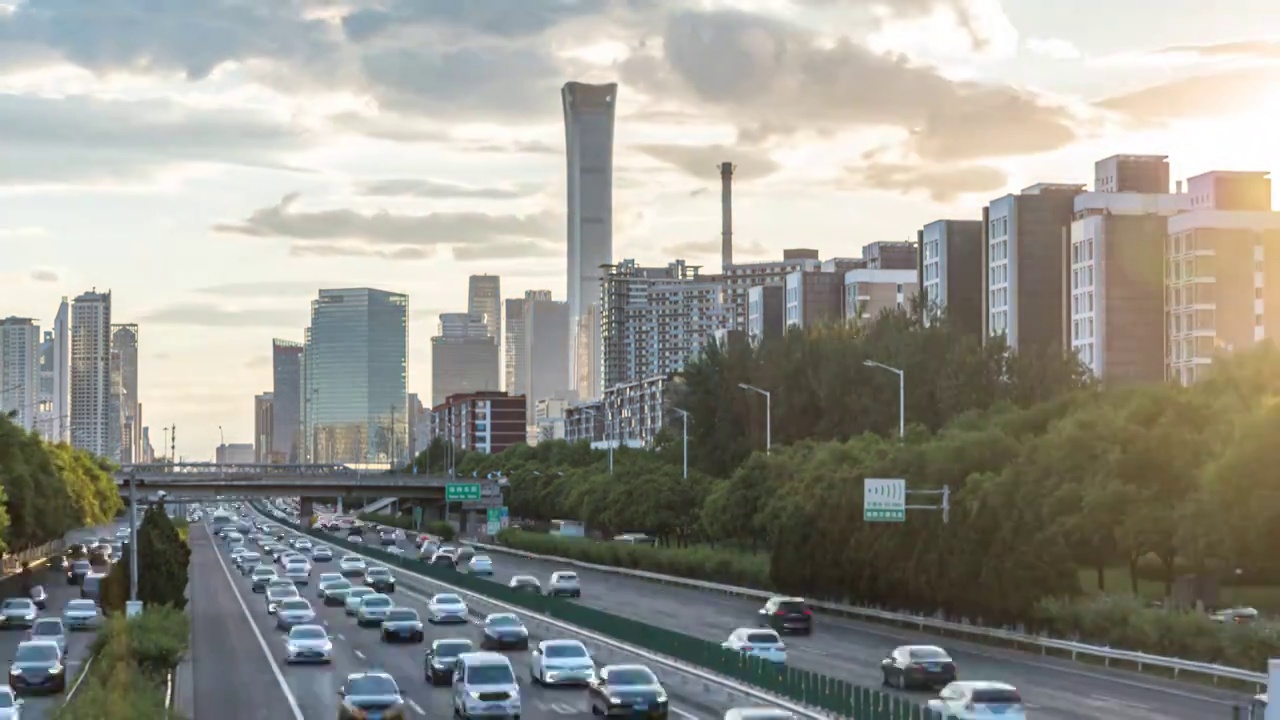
[{"x1": 498, "y1": 529, "x2": 1280, "y2": 669}]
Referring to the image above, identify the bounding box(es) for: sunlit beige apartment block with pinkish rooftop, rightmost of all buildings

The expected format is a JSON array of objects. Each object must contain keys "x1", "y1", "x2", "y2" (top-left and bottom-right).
[{"x1": 1165, "y1": 170, "x2": 1280, "y2": 384}]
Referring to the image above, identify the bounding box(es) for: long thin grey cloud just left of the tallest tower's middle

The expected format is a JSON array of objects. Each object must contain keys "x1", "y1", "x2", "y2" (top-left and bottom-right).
[{"x1": 214, "y1": 193, "x2": 562, "y2": 259}]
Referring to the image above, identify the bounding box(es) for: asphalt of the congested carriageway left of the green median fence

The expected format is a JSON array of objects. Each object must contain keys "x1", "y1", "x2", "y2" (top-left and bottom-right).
[{"x1": 191, "y1": 509, "x2": 747, "y2": 720}]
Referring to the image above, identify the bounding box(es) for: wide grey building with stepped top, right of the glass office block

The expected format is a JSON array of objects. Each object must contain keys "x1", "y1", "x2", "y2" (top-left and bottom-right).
[{"x1": 431, "y1": 313, "x2": 502, "y2": 407}]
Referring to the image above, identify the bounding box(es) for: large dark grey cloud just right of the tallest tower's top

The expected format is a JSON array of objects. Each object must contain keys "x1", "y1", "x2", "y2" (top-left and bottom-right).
[{"x1": 621, "y1": 10, "x2": 1076, "y2": 161}]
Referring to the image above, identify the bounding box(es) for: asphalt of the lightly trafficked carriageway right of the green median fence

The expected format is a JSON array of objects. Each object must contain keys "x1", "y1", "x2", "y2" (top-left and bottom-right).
[{"x1": 337, "y1": 527, "x2": 1247, "y2": 720}]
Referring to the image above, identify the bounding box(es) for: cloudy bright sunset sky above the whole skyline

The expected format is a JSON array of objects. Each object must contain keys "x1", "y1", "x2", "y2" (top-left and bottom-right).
[{"x1": 0, "y1": 0, "x2": 1280, "y2": 460}]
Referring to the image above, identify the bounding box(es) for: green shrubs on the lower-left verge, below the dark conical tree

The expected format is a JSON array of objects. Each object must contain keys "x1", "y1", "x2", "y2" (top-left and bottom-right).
[{"x1": 52, "y1": 606, "x2": 189, "y2": 720}]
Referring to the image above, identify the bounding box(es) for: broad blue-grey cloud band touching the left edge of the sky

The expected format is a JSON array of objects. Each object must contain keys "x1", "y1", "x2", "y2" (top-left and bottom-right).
[{"x1": 0, "y1": 95, "x2": 310, "y2": 184}]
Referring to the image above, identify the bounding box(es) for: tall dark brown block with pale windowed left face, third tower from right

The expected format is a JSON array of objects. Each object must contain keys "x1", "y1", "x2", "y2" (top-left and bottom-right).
[{"x1": 982, "y1": 183, "x2": 1084, "y2": 351}]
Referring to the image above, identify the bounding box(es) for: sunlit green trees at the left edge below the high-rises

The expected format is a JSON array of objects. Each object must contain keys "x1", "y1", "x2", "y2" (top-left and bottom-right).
[{"x1": 0, "y1": 414, "x2": 123, "y2": 551}]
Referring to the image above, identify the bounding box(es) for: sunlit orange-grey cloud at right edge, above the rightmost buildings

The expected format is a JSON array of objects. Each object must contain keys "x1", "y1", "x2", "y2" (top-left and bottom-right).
[{"x1": 1098, "y1": 67, "x2": 1280, "y2": 124}]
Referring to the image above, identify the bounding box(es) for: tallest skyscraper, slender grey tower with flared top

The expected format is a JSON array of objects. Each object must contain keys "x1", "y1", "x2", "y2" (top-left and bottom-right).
[{"x1": 561, "y1": 82, "x2": 618, "y2": 400}]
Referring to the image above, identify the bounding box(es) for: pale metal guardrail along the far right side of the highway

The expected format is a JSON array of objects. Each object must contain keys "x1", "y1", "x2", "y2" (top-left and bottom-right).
[{"x1": 465, "y1": 541, "x2": 1267, "y2": 692}]
